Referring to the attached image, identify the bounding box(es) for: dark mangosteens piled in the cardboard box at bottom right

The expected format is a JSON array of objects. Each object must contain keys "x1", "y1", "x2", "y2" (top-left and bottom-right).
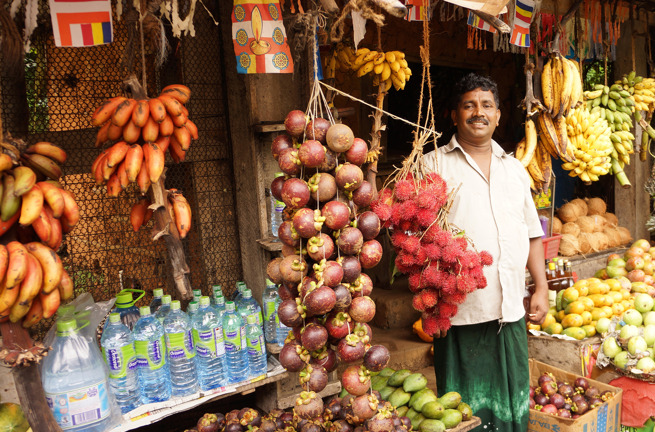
[{"x1": 530, "y1": 372, "x2": 614, "y2": 419}]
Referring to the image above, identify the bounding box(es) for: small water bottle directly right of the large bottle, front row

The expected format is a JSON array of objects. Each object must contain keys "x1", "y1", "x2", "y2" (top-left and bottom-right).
[{"x1": 100, "y1": 313, "x2": 141, "y2": 414}]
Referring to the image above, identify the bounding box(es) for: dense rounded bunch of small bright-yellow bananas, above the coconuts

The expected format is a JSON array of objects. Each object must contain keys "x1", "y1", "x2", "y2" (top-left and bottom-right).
[{"x1": 562, "y1": 105, "x2": 615, "y2": 183}]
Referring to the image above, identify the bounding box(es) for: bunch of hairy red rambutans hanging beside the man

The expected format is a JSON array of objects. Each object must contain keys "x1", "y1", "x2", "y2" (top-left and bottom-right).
[{"x1": 371, "y1": 172, "x2": 493, "y2": 336}]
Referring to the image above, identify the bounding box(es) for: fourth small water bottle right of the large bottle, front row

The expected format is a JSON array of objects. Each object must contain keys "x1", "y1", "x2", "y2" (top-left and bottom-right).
[{"x1": 193, "y1": 296, "x2": 226, "y2": 391}]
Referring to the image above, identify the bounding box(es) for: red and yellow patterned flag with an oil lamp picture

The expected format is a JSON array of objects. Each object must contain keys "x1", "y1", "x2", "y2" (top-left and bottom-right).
[{"x1": 232, "y1": 0, "x2": 293, "y2": 74}]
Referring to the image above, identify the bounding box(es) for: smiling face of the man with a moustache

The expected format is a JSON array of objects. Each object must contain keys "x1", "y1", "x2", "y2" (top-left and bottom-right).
[{"x1": 452, "y1": 88, "x2": 500, "y2": 144}]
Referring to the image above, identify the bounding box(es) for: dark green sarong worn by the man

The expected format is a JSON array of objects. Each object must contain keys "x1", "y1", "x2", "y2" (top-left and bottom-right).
[{"x1": 434, "y1": 318, "x2": 530, "y2": 432}]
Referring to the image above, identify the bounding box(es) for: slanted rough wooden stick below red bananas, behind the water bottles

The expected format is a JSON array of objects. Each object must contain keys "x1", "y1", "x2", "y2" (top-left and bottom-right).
[{"x1": 149, "y1": 171, "x2": 193, "y2": 300}]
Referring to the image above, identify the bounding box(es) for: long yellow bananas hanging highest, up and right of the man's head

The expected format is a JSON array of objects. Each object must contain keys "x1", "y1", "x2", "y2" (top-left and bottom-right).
[{"x1": 541, "y1": 53, "x2": 582, "y2": 118}]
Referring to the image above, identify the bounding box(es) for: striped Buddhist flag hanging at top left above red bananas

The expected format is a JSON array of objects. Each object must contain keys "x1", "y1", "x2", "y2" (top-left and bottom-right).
[{"x1": 49, "y1": 0, "x2": 114, "y2": 47}]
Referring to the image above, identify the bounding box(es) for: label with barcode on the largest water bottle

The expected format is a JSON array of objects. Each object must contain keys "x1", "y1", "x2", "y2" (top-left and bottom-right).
[{"x1": 45, "y1": 381, "x2": 111, "y2": 430}]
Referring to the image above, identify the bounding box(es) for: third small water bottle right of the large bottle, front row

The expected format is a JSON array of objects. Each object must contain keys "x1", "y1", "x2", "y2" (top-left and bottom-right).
[{"x1": 164, "y1": 300, "x2": 198, "y2": 396}]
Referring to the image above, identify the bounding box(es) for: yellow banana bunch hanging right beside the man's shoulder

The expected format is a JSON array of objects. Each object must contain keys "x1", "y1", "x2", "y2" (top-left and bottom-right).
[{"x1": 514, "y1": 117, "x2": 553, "y2": 192}]
